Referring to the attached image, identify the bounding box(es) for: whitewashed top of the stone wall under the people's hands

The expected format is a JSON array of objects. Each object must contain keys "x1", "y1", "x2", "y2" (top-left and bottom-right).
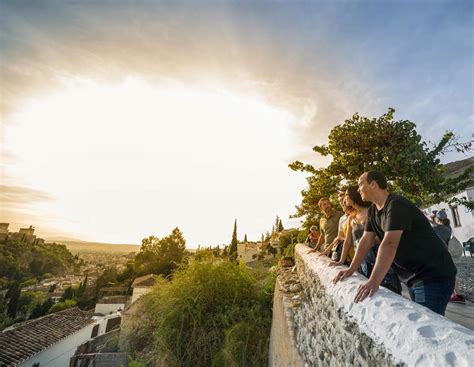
[{"x1": 295, "y1": 244, "x2": 474, "y2": 366}]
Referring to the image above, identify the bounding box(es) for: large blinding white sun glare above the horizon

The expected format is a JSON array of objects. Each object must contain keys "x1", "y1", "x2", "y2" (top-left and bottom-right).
[{"x1": 5, "y1": 78, "x2": 301, "y2": 246}]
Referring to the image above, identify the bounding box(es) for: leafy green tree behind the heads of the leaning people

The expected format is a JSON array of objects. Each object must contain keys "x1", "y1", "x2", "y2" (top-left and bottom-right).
[{"x1": 289, "y1": 108, "x2": 474, "y2": 225}]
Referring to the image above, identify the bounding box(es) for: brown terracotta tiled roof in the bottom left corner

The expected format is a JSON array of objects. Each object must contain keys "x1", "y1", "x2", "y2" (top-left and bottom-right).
[{"x1": 0, "y1": 307, "x2": 94, "y2": 367}]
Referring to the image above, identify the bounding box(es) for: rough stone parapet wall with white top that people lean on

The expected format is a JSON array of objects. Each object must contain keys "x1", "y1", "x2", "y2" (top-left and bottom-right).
[{"x1": 270, "y1": 244, "x2": 474, "y2": 367}]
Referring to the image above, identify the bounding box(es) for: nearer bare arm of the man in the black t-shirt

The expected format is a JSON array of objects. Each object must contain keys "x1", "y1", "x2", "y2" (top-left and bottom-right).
[{"x1": 354, "y1": 230, "x2": 403, "y2": 303}]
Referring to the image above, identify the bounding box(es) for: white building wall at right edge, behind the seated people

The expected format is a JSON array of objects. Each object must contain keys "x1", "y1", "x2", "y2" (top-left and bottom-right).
[{"x1": 425, "y1": 187, "x2": 474, "y2": 246}]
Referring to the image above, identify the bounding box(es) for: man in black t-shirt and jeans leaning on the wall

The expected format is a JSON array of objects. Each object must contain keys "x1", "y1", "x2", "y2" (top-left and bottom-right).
[{"x1": 334, "y1": 171, "x2": 456, "y2": 315}]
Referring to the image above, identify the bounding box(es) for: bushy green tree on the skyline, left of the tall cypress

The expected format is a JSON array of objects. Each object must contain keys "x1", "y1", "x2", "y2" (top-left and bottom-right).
[{"x1": 134, "y1": 228, "x2": 186, "y2": 276}]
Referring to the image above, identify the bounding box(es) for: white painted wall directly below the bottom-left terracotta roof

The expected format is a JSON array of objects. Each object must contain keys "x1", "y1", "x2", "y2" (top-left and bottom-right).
[{"x1": 19, "y1": 323, "x2": 96, "y2": 367}]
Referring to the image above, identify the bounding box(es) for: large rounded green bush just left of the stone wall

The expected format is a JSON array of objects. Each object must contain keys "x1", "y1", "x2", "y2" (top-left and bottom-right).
[{"x1": 124, "y1": 261, "x2": 271, "y2": 366}]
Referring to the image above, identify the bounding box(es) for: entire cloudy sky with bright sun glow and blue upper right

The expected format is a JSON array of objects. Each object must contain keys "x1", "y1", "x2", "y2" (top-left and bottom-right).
[{"x1": 0, "y1": 0, "x2": 474, "y2": 247}]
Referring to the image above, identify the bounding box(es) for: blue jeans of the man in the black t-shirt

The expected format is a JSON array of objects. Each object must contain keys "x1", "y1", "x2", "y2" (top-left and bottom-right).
[{"x1": 408, "y1": 278, "x2": 455, "y2": 316}]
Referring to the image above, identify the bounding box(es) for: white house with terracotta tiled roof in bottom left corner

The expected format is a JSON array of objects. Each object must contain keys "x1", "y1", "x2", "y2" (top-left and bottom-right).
[{"x1": 0, "y1": 307, "x2": 120, "y2": 367}]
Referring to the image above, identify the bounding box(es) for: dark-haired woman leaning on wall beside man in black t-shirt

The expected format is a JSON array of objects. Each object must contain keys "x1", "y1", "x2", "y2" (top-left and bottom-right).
[{"x1": 330, "y1": 186, "x2": 402, "y2": 294}]
